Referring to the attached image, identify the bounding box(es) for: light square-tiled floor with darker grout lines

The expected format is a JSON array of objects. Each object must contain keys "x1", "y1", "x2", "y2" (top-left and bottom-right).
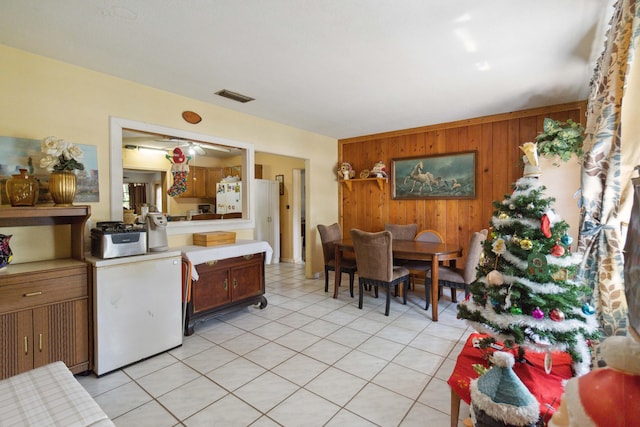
[{"x1": 76, "y1": 263, "x2": 472, "y2": 427}]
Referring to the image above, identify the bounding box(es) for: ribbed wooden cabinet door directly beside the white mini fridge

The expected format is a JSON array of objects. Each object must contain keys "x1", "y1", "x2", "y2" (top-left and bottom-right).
[{"x1": 32, "y1": 299, "x2": 89, "y2": 370}]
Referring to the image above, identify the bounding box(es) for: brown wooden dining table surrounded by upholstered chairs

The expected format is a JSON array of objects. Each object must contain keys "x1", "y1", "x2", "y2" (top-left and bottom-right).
[{"x1": 333, "y1": 239, "x2": 462, "y2": 322}]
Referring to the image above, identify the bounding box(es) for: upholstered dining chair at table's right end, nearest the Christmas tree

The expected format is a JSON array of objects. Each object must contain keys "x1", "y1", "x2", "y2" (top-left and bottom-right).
[{"x1": 424, "y1": 229, "x2": 489, "y2": 310}]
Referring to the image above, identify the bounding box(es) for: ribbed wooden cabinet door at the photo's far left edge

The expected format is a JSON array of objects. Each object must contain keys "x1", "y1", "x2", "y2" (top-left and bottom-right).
[{"x1": 0, "y1": 310, "x2": 33, "y2": 379}]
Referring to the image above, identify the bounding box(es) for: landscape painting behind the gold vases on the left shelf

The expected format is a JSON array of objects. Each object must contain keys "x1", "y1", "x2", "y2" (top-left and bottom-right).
[{"x1": 0, "y1": 136, "x2": 100, "y2": 205}]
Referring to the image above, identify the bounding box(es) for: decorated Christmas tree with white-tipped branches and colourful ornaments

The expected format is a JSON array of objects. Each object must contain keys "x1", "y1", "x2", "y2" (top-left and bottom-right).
[{"x1": 458, "y1": 138, "x2": 598, "y2": 375}]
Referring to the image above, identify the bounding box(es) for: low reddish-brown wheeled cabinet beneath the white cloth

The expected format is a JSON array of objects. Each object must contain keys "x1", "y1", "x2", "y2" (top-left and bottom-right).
[{"x1": 185, "y1": 253, "x2": 267, "y2": 335}]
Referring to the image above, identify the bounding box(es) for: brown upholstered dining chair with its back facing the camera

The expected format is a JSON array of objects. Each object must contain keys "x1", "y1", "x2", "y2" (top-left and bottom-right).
[{"x1": 350, "y1": 228, "x2": 409, "y2": 316}]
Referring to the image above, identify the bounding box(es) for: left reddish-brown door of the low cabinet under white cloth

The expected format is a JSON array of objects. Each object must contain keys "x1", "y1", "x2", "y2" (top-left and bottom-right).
[{"x1": 191, "y1": 266, "x2": 231, "y2": 313}]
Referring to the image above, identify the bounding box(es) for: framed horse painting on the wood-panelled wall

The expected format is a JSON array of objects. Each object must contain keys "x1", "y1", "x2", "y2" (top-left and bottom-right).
[{"x1": 391, "y1": 151, "x2": 477, "y2": 200}]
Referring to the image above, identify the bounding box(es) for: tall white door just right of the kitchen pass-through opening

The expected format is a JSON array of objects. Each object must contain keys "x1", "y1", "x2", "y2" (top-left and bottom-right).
[{"x1": 255, "y1": 179, "x2": 280, "y2": 264}]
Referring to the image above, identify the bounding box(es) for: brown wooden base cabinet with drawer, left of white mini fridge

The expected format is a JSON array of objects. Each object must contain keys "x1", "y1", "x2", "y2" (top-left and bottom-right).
[{"x1": 0, "y1": 260, "x2": 89, "y2": 378}]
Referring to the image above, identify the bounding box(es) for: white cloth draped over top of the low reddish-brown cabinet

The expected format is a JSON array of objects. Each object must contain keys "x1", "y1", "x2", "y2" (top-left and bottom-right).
[{"x1": 180, "y1": 240, "x2": 273, "y2": 280}]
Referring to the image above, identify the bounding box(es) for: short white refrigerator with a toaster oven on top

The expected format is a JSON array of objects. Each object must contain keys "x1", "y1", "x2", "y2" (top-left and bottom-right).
[{"x1": 87, "y1": 251, "x2": 182, "y2": 375}]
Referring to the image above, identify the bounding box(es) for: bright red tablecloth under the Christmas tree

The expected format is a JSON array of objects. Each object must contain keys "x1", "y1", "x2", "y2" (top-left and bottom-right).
[{"x1": 447, "y1": 334, "x2": 572, "y2": 418}]
